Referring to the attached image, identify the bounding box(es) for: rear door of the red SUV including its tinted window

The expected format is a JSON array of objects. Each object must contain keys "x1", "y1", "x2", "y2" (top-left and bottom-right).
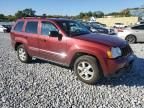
[{"x1": 23, "y1": 20, "x2": 39, "y2": 56}]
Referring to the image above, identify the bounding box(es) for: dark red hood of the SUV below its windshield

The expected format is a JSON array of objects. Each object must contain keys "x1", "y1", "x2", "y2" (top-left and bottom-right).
[{"x1": 75, "y1": 33, "x2": 127, "y2": 47}]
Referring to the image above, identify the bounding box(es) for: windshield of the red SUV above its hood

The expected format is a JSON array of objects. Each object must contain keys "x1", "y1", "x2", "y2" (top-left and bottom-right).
[{"x1": 57, "y1": 21, "x2": 90, "y2": 37}]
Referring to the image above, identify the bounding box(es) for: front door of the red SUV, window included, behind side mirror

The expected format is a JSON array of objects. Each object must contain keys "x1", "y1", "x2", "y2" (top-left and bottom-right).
[{"x1": 39, "y1": 21, "x2": 66, "y2": 63}]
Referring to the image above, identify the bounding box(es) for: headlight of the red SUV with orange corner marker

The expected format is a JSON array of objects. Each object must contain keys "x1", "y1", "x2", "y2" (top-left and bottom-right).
[{"x1": 107, "y1": 47, "x2": 122, "y2": 58}]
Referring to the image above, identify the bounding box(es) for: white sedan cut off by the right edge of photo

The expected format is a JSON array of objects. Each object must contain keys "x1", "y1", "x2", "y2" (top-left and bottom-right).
[{"x1": 118, "y1": 24, "x2": 144, "y2": 43}]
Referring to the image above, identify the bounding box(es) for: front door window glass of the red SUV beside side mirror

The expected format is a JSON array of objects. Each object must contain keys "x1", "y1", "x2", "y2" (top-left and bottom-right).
[{"x1": 41, "y1": 22, "x2": 58, "y2": 36}]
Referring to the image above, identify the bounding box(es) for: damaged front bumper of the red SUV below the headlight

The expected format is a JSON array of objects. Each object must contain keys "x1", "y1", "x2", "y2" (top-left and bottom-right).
[{"x1": 104, "y1": 54, "x2": 136, "y2": 77}]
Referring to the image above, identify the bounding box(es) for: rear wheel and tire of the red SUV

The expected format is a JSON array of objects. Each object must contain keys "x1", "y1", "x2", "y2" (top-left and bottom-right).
[{"x1": 17, "y1": 45, "x2": 32, "y2": 63}]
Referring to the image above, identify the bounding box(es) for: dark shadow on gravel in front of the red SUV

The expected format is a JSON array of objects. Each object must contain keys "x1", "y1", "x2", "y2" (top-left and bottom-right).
[{"x1": 97, "y1": 58, "x2": 144, "y2": 86}]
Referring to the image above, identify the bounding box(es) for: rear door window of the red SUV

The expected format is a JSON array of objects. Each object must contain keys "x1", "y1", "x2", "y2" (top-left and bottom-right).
[{"x1": 25, "y1": 22, "x2": 38, "y2": 34}]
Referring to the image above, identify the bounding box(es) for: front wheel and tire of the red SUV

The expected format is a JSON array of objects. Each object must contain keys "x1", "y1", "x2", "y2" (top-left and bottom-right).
[{"x1": 74, "y1": 55, "x2": 101, "y2": 85}]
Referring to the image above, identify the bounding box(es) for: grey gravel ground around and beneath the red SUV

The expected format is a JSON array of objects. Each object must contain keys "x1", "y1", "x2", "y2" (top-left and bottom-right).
[{"x1": 0, "y1": 33, "x2": 144, "y2": 108}]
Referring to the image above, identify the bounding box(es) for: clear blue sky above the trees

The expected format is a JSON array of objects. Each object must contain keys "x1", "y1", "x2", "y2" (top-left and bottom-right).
[{"x1": 0, "y1": 0, "x2": 144, "y2": 15}]
